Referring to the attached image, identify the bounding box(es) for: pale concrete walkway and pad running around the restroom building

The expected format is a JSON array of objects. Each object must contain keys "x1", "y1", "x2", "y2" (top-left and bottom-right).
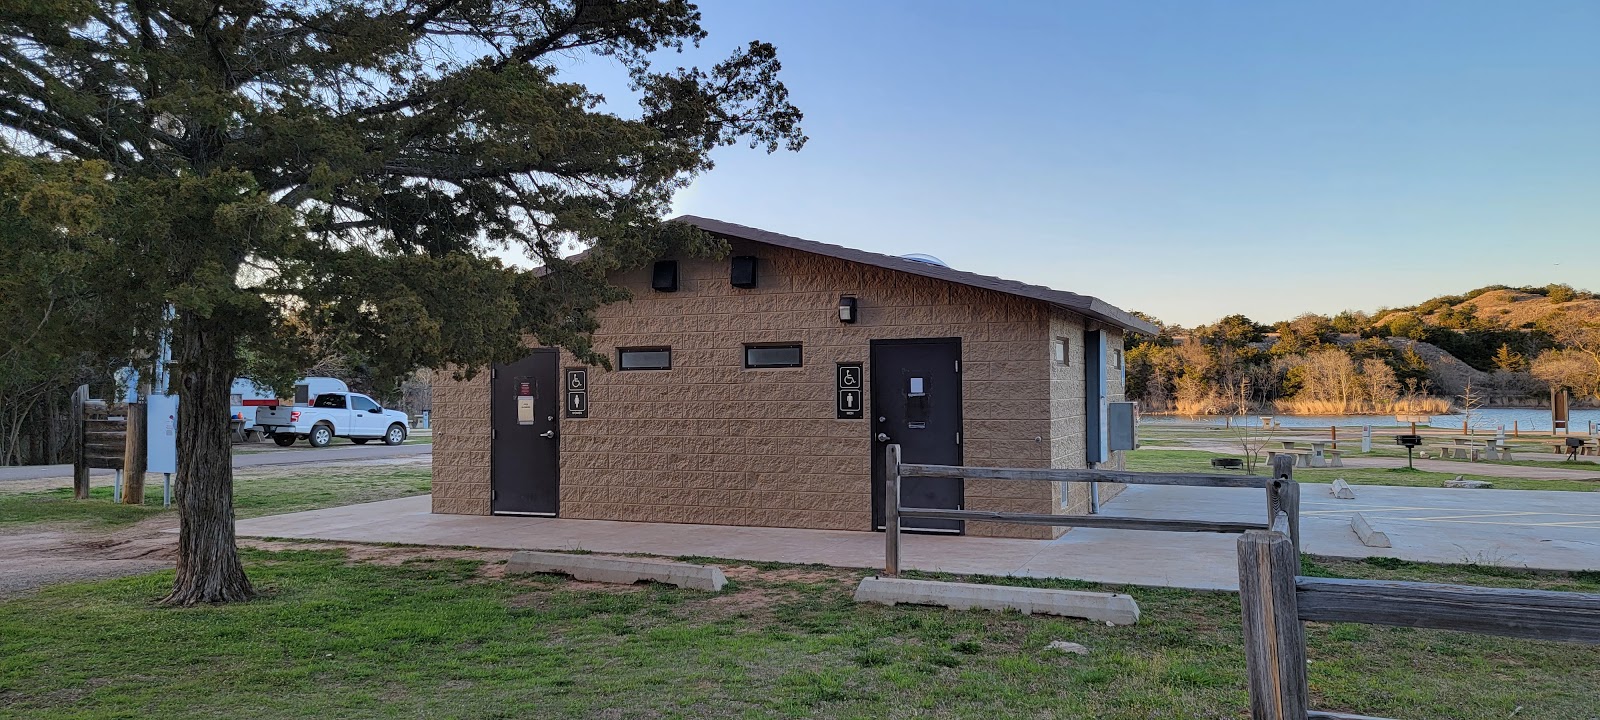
[{"x1": 238, "y1": 485, "x2": 1600, "y2": 590}]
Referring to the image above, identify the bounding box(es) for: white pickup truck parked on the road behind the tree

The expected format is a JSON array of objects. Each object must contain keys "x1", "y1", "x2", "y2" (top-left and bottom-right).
[{"x1": 256, "y1": 392, "x2": 411, "y2": 448}]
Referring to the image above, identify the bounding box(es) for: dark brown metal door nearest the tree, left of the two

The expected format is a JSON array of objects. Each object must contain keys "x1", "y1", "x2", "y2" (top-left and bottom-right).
[{"x1": 490, "y1": 350, "x2": 562, "y2": 517}]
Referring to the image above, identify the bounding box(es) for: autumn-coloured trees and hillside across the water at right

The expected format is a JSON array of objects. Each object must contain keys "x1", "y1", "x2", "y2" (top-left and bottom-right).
[{"x1": 1126, "y1": 285, "x2": 1600, "y2": 414}]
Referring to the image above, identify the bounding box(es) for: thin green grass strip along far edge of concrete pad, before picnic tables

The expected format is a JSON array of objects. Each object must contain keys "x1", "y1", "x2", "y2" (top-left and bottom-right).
[{"x1": 1128, "y1": 450, "x2": 1600, "y2": 493}]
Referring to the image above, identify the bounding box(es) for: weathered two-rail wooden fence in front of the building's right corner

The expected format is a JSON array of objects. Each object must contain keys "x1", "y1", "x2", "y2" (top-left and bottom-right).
[{"x1": 883, "y1": 445, "x2": 1299, "y2": 576}]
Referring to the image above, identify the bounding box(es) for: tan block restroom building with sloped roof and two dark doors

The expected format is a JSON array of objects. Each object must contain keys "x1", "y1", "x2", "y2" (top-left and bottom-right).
[{"x1": 432, "y1": 216, "x2": 1155, "y2": 538}]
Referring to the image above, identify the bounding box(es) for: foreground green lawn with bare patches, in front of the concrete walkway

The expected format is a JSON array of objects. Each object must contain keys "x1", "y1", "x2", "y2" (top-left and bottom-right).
[{"x1": 0, "y1": 549, "x2": 1600, "y2": 720}]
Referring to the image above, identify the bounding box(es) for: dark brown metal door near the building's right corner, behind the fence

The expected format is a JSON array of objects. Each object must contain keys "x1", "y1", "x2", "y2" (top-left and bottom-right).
[{"x1": 870, "y1": 338, "x2": 963, "y2": 533}]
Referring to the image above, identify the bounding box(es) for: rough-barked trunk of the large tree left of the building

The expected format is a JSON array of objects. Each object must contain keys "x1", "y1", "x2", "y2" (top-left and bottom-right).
[{"x1": 162, "y1": 312, "x2": 254, "y2": 605}]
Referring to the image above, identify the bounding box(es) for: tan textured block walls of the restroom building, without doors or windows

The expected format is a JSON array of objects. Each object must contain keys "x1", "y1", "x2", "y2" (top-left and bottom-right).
[{"x1": 434, "y1": 242, "x2": 1120, "y2": 538}]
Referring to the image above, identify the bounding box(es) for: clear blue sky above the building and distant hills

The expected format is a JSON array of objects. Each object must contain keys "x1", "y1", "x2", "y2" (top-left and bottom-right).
[{"x1": 556, "y1": 0, "x2": 1600, "y2": 325}]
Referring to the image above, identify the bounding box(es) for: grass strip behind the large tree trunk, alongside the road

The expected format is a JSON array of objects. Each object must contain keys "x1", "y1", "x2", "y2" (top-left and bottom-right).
[{"x1": 0, "y1": 467, "x2": 432, "y2": 528}]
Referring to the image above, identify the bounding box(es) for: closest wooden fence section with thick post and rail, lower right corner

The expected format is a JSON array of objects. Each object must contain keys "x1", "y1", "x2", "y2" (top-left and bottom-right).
[{"x1": 1238, "y1": 530, "x2": 1600, "y2": 720}]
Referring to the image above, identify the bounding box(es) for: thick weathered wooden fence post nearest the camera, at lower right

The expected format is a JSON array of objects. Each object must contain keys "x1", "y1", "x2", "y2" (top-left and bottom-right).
[{"x1": 1238, "y1": 530, "x2": 1309, "y2": 720}]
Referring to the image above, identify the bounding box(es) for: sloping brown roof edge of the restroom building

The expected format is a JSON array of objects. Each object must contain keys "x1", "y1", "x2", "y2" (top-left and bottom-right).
[{"x1": 672, "y1": 214, "x2": 1160, "y2": 334}]
